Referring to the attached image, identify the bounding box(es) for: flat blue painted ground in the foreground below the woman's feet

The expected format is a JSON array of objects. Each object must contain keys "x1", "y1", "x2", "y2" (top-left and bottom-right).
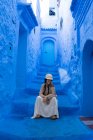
[{"x1": 0, "y1": 116, "x2": 93, "y2": 140}]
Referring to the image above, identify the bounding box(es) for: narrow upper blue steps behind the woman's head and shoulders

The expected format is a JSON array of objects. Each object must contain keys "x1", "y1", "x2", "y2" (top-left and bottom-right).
[{"x1": 28, "y1": 65, "x2": 62, "y2": 95}]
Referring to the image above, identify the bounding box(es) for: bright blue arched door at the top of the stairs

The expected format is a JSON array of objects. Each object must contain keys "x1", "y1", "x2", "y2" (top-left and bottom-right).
[{"x1": 42, "y1": 39, "x2": 55, "y2": 66}]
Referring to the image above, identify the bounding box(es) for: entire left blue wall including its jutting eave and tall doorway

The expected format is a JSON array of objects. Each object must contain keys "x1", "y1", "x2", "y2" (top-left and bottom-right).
[{"x1": 0, "y1": 0, "x2": 38, "y2": 115}]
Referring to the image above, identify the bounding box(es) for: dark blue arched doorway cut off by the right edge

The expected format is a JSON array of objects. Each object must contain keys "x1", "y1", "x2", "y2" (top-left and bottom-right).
[{"x1": 82, "y1": 40, "x2": 93, "y2": 116}]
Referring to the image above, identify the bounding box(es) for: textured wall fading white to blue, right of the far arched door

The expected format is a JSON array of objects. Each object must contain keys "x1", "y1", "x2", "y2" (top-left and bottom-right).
[{"x1": 57, "y1": 0, "x2": 80, "y2": 104}]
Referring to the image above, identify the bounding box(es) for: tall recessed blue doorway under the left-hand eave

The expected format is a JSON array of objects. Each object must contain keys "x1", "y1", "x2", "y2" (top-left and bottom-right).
[{"x1": 16, "y1": 23, "x2": 27, "y2": 88}]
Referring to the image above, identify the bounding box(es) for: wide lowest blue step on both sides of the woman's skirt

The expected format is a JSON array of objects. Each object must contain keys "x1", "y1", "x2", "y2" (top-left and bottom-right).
[{"x1": 11, "y1": 95, "x2": 79, "y2": 117}]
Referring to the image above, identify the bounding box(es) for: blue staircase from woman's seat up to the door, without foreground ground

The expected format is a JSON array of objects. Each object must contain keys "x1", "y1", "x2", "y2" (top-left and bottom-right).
[{"x1": 11, "y1": 66, "x2": 79, "y2": 117}]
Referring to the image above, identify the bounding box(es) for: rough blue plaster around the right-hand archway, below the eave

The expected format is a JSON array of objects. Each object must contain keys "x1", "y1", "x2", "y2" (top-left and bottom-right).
[{"x1": 70, "y1": 1, "x2": 93, "y2": 99}]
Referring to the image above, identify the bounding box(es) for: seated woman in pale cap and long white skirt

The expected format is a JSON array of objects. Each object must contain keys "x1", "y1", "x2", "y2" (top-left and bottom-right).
[{"x1": 33, "y1": 74, "x2": 59, "y2": 119}]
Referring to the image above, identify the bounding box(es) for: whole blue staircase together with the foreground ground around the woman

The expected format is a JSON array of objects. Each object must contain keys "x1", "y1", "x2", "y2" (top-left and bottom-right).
[{"x1": 0, "y1": 66, "x2": 93, "y2": 140}]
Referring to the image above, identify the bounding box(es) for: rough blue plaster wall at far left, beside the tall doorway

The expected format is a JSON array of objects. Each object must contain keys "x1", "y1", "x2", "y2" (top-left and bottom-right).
[{"x1": 0, "y1": 0, "x2": 18, "y2": 107}]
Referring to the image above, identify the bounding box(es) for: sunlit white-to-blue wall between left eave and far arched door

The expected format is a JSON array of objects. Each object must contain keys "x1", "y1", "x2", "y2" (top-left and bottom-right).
[{"x1": 26, "y1": 0, "x2": 41, "y2": 87}]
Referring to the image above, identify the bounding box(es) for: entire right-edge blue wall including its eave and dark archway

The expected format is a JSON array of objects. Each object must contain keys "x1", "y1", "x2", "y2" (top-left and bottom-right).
[{"x1": 71, "y1": 0, "x2": 93, "y2": 116}]
